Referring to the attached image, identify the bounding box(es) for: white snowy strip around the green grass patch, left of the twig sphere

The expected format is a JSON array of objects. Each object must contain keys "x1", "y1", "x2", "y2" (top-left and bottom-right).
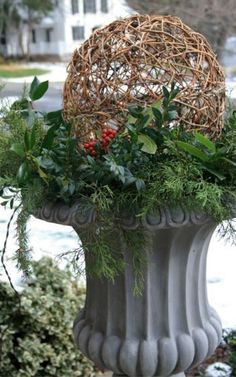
[{"x1": 0, "y1": 63, "x2": 68, "y2": 84}]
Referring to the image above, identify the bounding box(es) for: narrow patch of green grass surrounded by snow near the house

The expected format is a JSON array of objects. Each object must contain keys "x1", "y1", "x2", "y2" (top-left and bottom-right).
[{"x1": 0, "y1": 64, "x2": 49, "y2": 78}]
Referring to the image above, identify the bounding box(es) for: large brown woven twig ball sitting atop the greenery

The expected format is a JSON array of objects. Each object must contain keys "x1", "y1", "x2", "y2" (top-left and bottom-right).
[{"x1": 64, "y1": 15, "x2": 225, "y2": 139}]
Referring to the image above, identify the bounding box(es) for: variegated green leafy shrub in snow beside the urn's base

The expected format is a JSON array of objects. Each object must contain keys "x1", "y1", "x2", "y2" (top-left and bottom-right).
[{"x1": 0, "y1": 258, "x2": 97, "y2": 377}]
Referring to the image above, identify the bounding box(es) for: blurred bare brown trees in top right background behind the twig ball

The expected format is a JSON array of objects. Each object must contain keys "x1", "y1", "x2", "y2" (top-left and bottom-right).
[{"x1": 126, "y1": 0, "x2": 236, "y2": 57}]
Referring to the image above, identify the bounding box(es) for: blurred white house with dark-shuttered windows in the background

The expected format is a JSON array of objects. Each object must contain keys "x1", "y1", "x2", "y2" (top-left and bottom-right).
[{"x1": 1, "y1": 0, "x2": 128, "y2": 59}]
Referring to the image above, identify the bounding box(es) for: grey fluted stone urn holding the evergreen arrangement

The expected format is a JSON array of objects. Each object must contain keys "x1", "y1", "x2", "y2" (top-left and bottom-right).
[{"x1": 37, "y1": 203, "x2": 221, "y2": 377}]
